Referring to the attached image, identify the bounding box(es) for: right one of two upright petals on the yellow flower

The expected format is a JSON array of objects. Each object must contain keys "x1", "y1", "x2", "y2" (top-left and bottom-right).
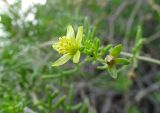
[{"x1": 76, "y1": 26, "x2": 83, "y2": 46}]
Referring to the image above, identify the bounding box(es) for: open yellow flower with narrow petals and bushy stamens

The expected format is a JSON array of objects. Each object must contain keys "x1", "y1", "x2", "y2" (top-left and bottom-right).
[{"x1": 52, "y1": 25, "x2": 83, "y2": 66}]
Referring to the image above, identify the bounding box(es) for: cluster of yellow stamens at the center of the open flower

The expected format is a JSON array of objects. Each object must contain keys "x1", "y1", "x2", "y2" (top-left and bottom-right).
[{"x1": 53, "y1": 36, "x2": 78, "y2": 54}]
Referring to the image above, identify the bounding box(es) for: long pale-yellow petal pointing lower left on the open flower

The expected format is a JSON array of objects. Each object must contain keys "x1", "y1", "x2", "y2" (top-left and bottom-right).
[{"x1": 52, "y1": 54, "x2": 72, "y2": 66}]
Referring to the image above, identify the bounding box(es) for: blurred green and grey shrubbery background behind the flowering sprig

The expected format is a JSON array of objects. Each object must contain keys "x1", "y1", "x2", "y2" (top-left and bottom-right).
[{"x1": 0, "y1": 0, "x2": 160, "y2": 113}]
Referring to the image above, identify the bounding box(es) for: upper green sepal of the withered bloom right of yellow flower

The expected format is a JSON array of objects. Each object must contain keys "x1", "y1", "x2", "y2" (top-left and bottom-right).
[{"x1": 110, "y1": 44, "x2": 122, "y2": 57}]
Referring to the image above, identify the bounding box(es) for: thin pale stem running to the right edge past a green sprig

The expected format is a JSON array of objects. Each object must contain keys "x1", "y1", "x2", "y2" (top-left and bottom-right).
[{"x1": 121, "y1": 52, "x2": 160, "y2": 65}]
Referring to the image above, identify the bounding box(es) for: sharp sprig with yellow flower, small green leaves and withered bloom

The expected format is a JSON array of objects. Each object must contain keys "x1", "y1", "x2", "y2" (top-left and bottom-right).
[{"x1": 52, "y1": 25, "x2": 129, "y2": 78}]
